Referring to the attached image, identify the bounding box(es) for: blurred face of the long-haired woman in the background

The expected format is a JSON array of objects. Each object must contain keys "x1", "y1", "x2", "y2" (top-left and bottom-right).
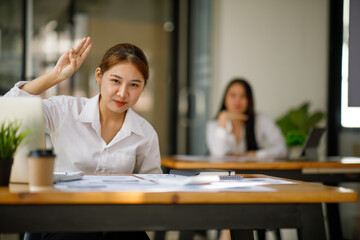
[{"x1": 225, "y1": 83, "x2": 249, "y2": 113}]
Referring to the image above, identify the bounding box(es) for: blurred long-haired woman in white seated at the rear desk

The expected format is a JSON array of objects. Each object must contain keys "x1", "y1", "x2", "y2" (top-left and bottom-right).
[{"x1": 206, "y1": 79, "x2": 287, "y2": 158}]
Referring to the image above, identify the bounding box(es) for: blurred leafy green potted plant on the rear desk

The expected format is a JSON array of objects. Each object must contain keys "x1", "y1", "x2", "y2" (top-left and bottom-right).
[{"x1": 276, "y1": 102, "x2": 325, "y2": 159}]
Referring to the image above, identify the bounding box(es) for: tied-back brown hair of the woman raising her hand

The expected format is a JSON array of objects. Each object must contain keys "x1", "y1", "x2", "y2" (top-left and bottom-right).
[{"x1": 99, "y1": 43, "x2": 149, "y2": 85}]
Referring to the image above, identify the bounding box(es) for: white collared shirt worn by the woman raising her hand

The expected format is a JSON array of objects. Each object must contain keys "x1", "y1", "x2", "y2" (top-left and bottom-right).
[{"x1": 5, "y1": 81, "x2": 162, "y2": 174}]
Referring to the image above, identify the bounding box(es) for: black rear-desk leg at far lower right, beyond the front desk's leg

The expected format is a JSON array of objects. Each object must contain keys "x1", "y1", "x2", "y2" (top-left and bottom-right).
[{"x1": 326, "y1": 203, "x2": 343, "y2": 240}]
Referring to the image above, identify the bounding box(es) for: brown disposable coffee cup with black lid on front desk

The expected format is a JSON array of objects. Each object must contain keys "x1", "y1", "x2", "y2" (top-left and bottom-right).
[{"x1": 28, "y1": 149, "x2": 55, "y2": 192}]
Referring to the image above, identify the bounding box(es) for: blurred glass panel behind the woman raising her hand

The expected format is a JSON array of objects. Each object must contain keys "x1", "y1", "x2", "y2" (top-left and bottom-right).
[{"x1": 0, "y1": 0, "x2": 173, "y2": 154}]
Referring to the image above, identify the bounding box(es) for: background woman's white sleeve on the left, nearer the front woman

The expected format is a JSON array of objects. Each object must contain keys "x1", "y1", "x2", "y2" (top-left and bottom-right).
[{"x1": 206, "y1": 120, "x2": 232, "y2": 156}]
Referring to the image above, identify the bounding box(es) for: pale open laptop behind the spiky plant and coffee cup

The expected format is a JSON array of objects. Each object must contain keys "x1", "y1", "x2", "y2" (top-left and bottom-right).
[{"x1": 0, "y1": 97, "x2": 45, "y2": 183}]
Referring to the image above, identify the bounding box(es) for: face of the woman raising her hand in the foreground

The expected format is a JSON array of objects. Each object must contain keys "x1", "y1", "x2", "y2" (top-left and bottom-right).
[{"x1": 95, "y1": 63, "x2": 145, "y2": 113}]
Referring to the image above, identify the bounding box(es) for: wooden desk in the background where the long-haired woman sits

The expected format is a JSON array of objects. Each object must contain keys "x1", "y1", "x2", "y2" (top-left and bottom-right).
[{"x1": 161, "y1": 156, "x2": 360, "y2": 240}]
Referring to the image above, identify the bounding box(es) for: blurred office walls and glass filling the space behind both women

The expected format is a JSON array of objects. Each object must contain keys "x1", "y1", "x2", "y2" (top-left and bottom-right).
[{"x1": 0, "y1": 0, "x2": 360, "y2": 239}]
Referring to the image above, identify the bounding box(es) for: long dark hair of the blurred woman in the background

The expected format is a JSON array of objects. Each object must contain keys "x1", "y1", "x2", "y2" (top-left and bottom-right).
[{"x1": 216, "y1": 78, "x2": 258, "y2": 151}]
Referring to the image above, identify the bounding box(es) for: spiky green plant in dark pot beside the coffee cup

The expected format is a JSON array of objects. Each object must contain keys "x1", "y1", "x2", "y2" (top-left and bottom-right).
[{"x1": 0, "y1": 121, "x2": 29, "y2": 186}]
